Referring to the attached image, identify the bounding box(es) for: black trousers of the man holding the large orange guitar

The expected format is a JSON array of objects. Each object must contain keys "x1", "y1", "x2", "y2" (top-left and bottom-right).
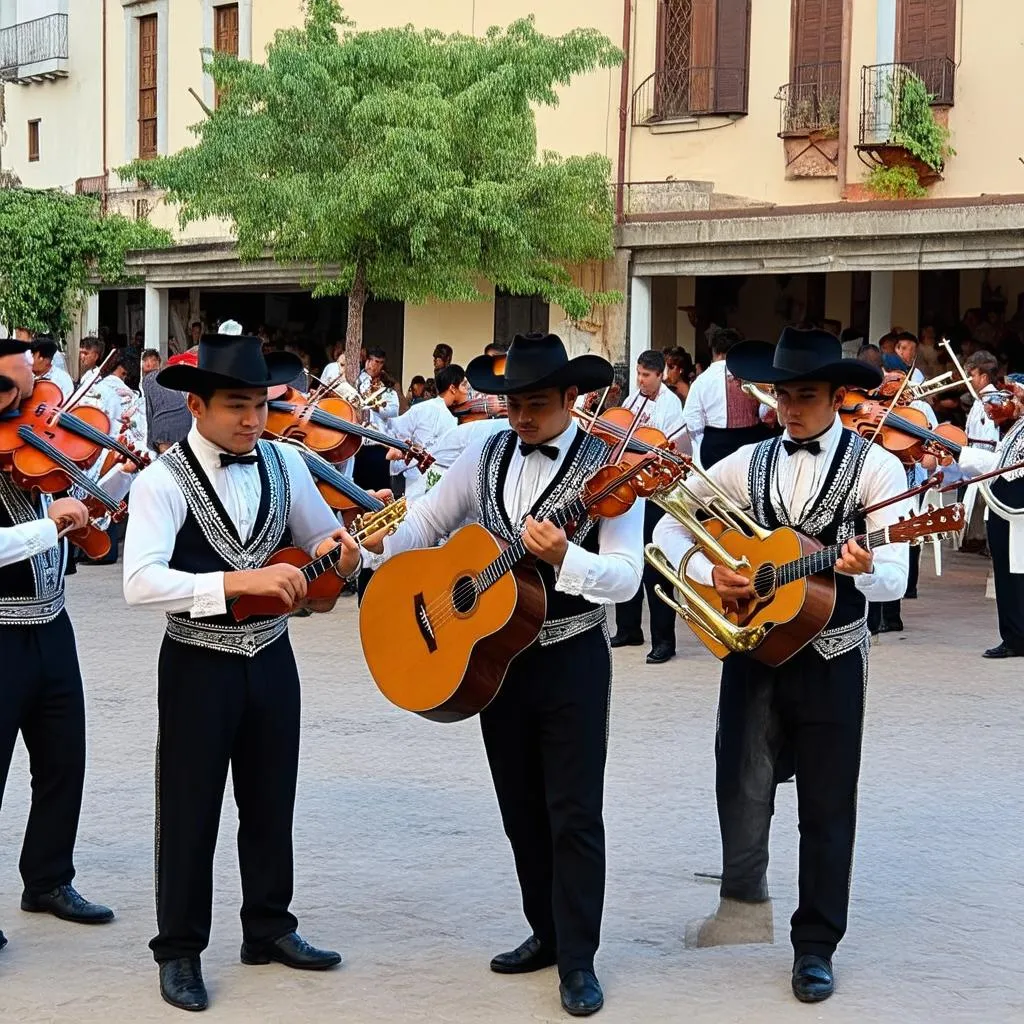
[{"x1": 480, "y1": 629, "x2": 611, "y2": 977}]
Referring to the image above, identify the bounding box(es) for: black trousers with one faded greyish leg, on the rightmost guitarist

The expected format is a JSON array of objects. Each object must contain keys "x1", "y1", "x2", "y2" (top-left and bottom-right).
[{"x1": 716, "y1": 648, "x2": 866, "y2": 956}]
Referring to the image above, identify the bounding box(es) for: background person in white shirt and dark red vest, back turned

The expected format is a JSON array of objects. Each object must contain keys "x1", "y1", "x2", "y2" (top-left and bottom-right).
[{"x1": 683, "y1": 328, "x2": 773, "y2": 469}]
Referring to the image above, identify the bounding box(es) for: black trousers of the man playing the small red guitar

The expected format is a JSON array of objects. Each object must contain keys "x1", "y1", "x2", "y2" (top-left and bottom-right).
[{"x1": 150, "y1": 637, "x2": 299, "y2": 963}]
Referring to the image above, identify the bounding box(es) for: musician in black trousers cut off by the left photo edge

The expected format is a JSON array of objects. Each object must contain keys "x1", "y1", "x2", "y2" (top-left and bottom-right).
[{"x1": 0, "y1": 340, "x2": 130, "y2": 947}]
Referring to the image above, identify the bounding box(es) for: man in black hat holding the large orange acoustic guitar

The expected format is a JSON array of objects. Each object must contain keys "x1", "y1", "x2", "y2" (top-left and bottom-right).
[{"x1": 364, "y1": 335, "x2": 643, "y2": 1016}]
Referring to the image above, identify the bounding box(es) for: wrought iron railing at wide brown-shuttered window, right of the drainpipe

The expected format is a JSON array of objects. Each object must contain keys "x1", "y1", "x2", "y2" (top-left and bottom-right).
[{"x1": 633, "y1": 68, "x2": 746, "y2": 127}]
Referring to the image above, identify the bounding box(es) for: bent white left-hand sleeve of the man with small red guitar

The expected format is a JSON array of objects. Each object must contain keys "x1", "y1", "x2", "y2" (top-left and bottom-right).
[{"x1": 124, "y1": 462, "x2": 227, "y2": 618}]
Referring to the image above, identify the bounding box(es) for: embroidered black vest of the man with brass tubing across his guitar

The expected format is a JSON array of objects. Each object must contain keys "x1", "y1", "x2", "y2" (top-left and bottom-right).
[{"x1": 748, "y1": 428, "x2": 871, "y2": 658}]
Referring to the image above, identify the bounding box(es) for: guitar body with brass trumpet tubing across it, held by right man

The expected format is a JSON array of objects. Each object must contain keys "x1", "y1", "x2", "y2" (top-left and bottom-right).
[{"x1": 690, "y1": 526, "x2": 836, "y2": 668}]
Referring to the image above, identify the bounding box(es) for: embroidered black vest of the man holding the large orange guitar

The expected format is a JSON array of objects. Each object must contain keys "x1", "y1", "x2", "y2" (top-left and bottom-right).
[{"x1": 477, "y1": 430, "x2": 608, "y2": 646}]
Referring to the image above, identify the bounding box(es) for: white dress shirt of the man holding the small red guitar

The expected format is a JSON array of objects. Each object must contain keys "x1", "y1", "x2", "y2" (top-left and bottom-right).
[{"x1": 124, "y1": 424, "x2": 338, "y2": 618}]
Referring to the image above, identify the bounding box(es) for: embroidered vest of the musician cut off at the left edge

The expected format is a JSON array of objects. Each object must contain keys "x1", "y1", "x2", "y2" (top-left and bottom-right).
[{"x1": 0, "y1": 473, "x2": 68, "y2": 626}]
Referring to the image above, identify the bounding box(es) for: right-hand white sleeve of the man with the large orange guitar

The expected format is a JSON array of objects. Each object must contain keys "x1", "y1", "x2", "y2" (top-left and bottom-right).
[{"x1": 555, "y1": 500, "x2": 644, "y2": 604}]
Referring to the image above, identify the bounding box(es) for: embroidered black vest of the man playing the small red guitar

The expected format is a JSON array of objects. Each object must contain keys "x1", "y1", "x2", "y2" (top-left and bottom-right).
[{"x1": 161, "y1": 440, "x2": 291, "y2": 657}]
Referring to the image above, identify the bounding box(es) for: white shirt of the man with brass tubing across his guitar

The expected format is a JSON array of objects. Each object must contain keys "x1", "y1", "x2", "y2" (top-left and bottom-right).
[{"x1": 653, "y1": 416, "x2": 912, "y2": 601}]
